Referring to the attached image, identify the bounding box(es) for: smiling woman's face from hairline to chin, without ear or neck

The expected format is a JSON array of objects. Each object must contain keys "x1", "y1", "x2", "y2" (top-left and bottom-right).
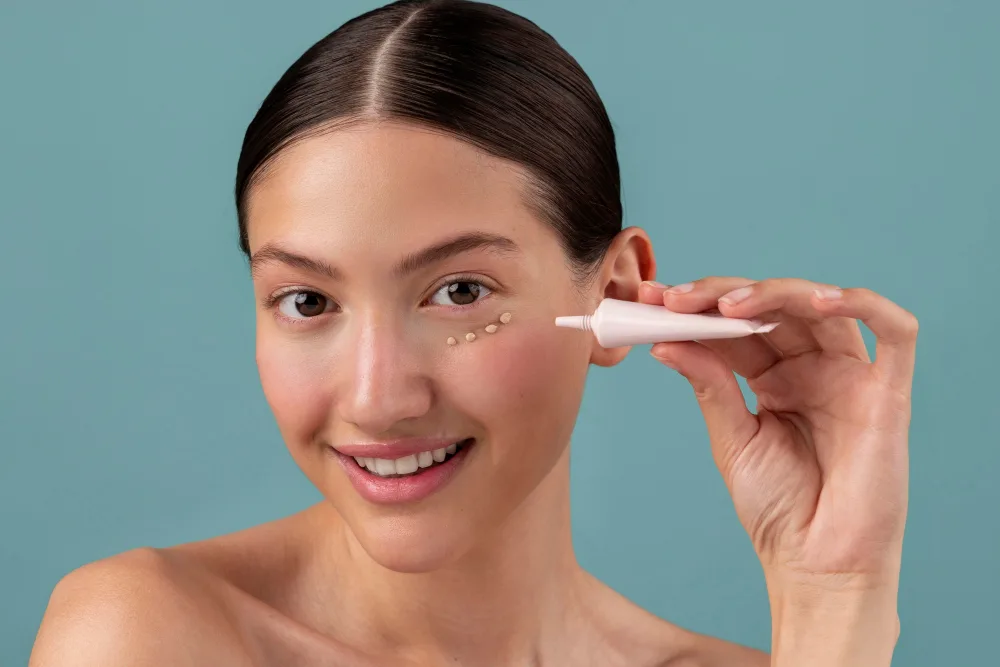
[{"x1": 247, "y1": 123, "x2": 596, "y2": 571}]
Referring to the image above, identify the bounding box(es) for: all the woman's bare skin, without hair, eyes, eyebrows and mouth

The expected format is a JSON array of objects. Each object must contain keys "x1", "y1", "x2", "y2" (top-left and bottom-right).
[{"x1": 31, "y1": 122, "x2": 916, "y2": 666}]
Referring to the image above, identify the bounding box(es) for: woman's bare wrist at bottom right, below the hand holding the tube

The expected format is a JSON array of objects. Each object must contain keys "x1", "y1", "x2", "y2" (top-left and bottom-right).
[{"x1": 768, "y1": 575, "x2": 899, "y2": 667}]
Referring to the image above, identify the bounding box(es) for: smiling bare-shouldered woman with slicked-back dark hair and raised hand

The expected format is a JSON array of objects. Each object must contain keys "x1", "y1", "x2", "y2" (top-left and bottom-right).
[{"x1": 32, "y1": 0, "x2": 916, "y2": 667}]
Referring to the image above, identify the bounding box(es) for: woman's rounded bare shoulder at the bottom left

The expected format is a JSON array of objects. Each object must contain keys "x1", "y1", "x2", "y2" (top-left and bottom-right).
[{"x1": 29, "y1": 548, "x2": 247, "y2": 667}]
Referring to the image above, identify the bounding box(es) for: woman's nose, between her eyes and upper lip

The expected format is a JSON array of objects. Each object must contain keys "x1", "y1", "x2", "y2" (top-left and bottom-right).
[{"x1": 340, "y1": 316, "x2": 433, "y2": 437}]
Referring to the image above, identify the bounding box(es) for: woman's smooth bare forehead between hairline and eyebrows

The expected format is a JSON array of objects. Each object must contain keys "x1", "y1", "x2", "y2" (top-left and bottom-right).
[{"x1": 247, "y1": 122, "x2": 534, "y2": 252}]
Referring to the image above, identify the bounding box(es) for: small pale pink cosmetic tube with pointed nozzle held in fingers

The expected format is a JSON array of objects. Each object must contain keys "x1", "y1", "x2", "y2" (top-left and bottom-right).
[{"x1": 556, "y1": 299, "x2": 778, "y2": 348}]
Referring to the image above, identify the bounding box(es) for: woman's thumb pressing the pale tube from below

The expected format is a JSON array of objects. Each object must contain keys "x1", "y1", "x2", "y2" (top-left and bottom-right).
[{"x1": 650, "y1": 341, "x2": 758, "y2": 485}]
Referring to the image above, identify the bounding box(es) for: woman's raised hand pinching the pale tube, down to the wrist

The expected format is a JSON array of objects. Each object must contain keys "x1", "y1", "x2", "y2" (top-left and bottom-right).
[{"x1": 639, "y1": 278, "x2": 917, "y2": 604}]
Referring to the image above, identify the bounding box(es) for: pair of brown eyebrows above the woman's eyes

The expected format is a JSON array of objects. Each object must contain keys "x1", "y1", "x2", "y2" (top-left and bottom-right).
[{"x1": 250, "y1": 232, "x2": 520, "y2": 280}]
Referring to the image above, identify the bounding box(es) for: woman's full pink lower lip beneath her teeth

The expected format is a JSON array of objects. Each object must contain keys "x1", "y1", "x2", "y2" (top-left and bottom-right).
[{"x1": 330, "y1": 442, "x2": 476, "y2": 505}]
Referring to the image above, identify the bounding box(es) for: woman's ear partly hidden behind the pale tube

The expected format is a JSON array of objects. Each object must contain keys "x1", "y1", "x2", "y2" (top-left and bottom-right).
[{"x1": 590, "y1": 227, "x2": 656, "y2": 366}]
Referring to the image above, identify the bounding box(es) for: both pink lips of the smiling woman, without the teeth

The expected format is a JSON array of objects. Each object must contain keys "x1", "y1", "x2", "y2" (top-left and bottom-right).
[{"x1": 331, "y1": 441, "x2": 475, "y2": 505}]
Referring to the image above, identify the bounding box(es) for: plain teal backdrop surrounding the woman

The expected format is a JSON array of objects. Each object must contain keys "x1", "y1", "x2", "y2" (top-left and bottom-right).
[{"x1": 0, "y1": 0, "x2": 1000, "y2": 667}]
